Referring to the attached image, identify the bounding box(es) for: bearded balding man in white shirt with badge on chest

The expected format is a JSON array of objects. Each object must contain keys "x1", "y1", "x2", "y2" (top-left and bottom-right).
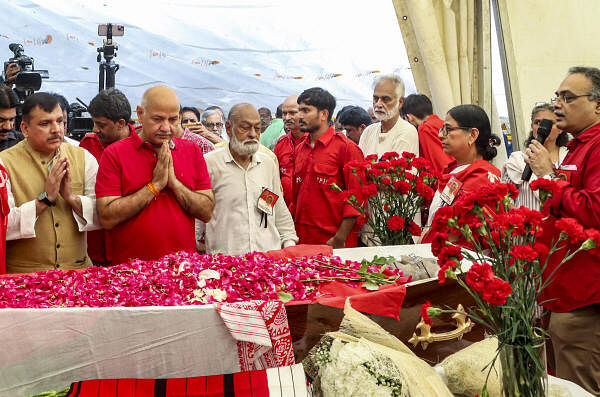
[{"x1": 205, "y1": 103, "x2": 298, "y2": 255}]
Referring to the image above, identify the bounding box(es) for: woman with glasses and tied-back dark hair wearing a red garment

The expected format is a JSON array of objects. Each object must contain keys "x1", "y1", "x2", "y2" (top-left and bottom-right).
[{"x1": 421, "y1": 105, "x2": 500, "y2": 243}]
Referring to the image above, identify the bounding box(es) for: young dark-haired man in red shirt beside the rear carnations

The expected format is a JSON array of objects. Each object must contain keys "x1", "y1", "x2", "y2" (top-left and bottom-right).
[{"x1": 294, "y1": 87, "x2": 363, "y2": 248}]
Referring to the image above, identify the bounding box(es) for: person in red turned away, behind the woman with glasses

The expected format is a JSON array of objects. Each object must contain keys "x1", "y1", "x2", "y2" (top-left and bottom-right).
[{"x1": 402, "y1": 94, "x2": 454, "y2": 173}]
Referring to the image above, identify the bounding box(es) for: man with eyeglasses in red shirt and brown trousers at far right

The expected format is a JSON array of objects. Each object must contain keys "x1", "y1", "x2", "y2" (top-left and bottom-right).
[{"x1": 526, "y1": 67, "x2": 600, "y2": 396}]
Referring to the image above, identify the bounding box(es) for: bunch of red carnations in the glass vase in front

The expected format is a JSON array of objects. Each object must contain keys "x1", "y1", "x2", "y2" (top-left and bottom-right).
[{"x1": 423, "y1": 183, "x2": 600, "y2": 374}]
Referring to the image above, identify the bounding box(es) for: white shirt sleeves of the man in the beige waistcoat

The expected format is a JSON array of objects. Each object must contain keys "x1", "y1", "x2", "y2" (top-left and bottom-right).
[{"x1": 0, "y1": 149, "x2": 102, "y2": 240}]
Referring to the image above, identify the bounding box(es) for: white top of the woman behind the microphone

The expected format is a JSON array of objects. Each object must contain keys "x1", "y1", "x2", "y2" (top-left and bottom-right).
[{"x1": 502, "y1": 146, "x2": 569, "y2": 210}]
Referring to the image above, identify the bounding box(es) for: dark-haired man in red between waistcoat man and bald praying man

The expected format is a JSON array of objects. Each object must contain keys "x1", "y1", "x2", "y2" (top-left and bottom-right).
[{"x1": 79, "y1": 88, "x2": 135, "y2": 266}]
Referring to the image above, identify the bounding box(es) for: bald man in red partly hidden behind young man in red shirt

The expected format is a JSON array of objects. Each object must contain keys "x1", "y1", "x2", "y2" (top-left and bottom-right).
[{"x1": 273, "y1": 95, "x2": 306, "y2": 214}]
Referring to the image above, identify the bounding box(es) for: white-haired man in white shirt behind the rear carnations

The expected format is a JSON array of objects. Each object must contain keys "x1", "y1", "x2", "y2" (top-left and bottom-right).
[{"x1": 358, "y1": 74, "x2": 419, "y2": 158}]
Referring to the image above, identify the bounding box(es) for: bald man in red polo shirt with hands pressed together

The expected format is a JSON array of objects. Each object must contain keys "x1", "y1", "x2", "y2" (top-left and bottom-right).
[{"x1": 96, "y1": 86, "x2": 215, "y2": 264}]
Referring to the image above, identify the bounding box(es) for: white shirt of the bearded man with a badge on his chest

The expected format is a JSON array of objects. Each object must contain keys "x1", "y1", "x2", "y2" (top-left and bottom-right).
[{"x1": 204, "y1": 145, "x2": 298, "y2": 255}]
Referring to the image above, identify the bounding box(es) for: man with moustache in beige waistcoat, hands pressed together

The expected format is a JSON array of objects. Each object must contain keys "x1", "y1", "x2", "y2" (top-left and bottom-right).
[{"x1": 0, "y1": 92, "x2": 100, "y2": 273}]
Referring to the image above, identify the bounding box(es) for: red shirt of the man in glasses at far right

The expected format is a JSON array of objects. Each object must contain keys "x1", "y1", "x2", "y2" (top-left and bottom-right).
[{"x1": 540, "y1": 123, "x2": 600, "y2": 312}]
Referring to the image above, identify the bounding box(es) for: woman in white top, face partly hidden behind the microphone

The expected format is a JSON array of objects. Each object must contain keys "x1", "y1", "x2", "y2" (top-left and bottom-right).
[{"x1": 502, "y1": 103, "x2": 569, "y2": 210}]
